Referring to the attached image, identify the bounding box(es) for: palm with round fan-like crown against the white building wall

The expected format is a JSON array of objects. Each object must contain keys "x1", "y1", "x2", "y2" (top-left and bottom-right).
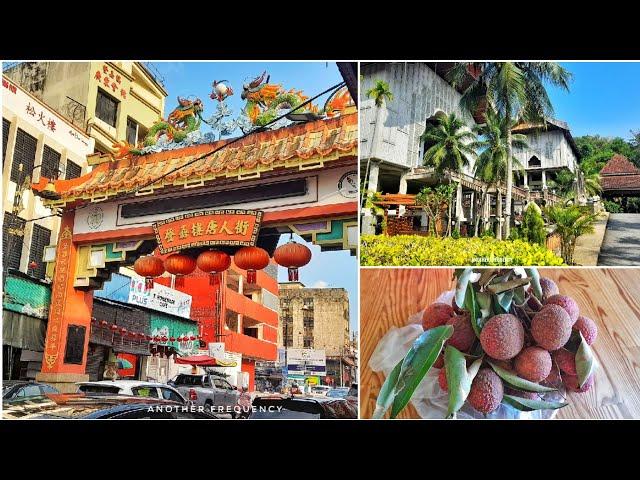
[{"x1": 421, "y1": 112, "x2": 478, "y2": 235}]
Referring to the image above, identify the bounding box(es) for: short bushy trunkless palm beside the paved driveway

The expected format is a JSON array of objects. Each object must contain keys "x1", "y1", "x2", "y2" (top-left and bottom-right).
[{"x1": 545, "y1": 205, "x2": 598, "y2": 265}]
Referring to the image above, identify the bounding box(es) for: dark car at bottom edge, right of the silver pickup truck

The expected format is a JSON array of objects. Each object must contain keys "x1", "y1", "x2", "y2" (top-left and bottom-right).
[{"x1": 249, "y1": 395, "x2": 358, "y2": 420}]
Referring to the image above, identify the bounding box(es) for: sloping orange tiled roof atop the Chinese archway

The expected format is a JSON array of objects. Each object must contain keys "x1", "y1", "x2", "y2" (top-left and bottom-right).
[{"x1": 32, "y1": 113, "x2": 358, "y2": 205}]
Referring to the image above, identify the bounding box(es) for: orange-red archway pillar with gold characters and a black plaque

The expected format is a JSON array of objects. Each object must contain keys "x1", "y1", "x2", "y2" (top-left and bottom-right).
[{"x1": 36, "y1": 211, "x2": 93, "y2": 393}]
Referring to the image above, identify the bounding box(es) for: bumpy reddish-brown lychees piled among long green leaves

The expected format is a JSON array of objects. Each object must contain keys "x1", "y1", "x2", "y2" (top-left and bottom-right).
[{"x1": 422, "y1": 277, "x2": 598, "y2": 413}]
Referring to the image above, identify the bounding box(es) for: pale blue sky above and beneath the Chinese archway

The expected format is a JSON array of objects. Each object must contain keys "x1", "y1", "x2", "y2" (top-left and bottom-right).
[{"x1": 154, "y1": 62, "x2": 358, "y2": 331}]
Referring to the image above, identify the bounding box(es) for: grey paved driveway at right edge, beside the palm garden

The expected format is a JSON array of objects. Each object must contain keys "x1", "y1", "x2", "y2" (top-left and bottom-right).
[{"x1": 598, "y1": 213, "x2": 640, "y2": 266}]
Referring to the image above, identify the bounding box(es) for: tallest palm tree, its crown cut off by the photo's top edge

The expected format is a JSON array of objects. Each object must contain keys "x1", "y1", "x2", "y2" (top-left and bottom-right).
[{"x1": 449, "y1": 62, "x2": 571, "y2": 238}]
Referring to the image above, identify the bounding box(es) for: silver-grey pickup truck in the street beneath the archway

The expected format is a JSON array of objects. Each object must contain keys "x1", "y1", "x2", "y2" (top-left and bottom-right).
[{"x1": 171, "y1": 373, "x2": 240, "y2": 417}]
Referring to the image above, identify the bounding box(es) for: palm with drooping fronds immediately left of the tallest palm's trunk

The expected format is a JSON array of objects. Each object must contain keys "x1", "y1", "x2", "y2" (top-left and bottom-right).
[{"x1": 473, "y1": 107, "x2": 528, "y2": 239}]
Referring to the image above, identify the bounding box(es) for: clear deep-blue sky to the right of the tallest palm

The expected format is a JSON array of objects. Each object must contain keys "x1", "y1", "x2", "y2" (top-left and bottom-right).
[{"x1": 549, "y1": 62, "x2": 640, "y2": 140}]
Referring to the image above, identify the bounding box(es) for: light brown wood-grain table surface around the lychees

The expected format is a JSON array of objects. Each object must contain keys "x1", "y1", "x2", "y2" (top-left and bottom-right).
[{"x1": 360, "y1": 267, "x2": 640, "y2": 419}]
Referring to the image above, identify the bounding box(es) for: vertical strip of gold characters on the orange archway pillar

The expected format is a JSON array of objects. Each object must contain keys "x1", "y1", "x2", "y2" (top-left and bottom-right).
[{"x1": 44, "y1": 226, "x2": 71, "y2": 369}]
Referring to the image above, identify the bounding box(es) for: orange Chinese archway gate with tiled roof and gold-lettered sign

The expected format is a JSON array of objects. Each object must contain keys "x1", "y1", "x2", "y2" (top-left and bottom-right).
[{"x1": 33, "y1": 108, "x2": 358, "y2": 391}]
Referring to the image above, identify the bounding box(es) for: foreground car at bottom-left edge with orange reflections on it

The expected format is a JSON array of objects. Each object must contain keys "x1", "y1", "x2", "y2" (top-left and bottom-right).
[{"x1": 2, "y1": 393, "x2": 218, "y2": 420}]
